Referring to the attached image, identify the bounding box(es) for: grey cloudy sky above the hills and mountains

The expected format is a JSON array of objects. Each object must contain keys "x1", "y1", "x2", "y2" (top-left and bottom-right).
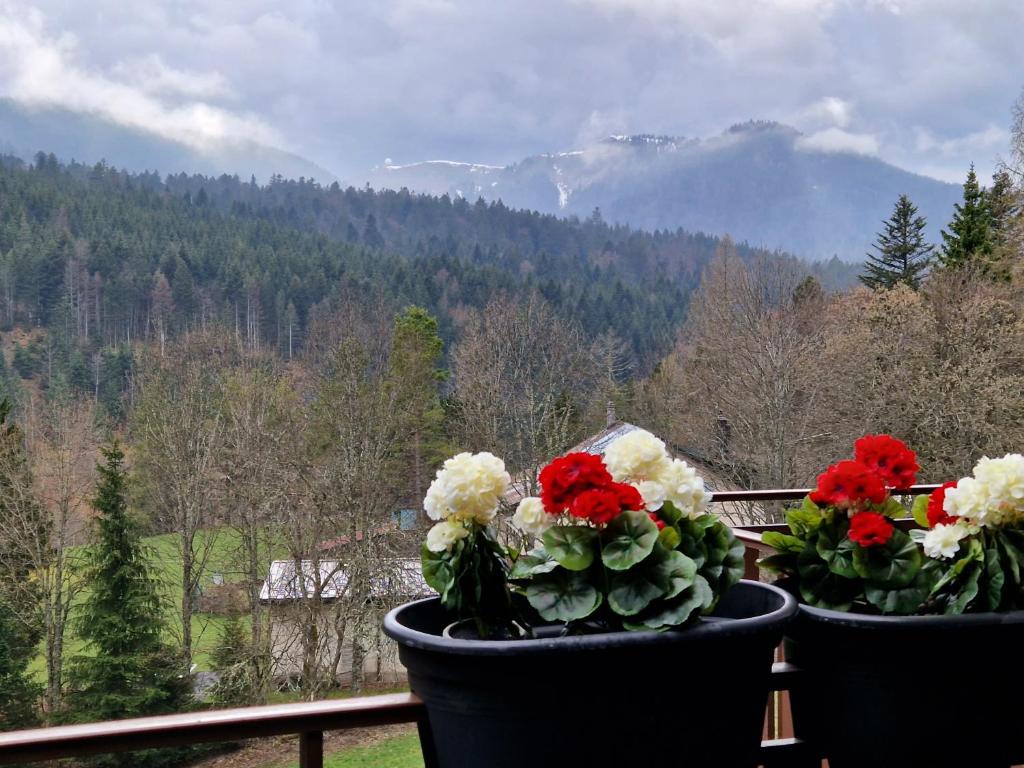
[{"x1": 0, "y1": 0, "x2": 1024, "y2": 180}]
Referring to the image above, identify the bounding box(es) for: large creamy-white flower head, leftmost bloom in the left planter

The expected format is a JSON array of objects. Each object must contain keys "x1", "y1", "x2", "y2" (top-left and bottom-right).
[{"x1": 423, "y1": 453, "x2": 512, "y2": 523}]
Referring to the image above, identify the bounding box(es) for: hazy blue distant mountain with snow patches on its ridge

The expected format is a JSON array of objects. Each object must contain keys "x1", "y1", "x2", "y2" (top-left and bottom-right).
[{"x1": 358, "y1": 122, "x2": 961, "y2": 261}]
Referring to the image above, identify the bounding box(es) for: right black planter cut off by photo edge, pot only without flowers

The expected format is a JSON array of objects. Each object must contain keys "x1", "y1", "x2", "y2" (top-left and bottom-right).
[{"x1": 785, "y1": 605, "x2": 1024, "y2": 768}]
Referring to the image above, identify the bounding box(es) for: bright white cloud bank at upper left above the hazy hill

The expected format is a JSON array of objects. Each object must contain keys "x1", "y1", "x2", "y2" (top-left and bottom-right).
[{"x1": 0, "y1": 5, "x2": 280, "y2": 148}]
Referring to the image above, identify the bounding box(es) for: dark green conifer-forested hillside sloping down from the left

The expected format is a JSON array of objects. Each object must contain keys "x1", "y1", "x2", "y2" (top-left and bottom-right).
[{"x1": 0, "y1": 155, "x2": 850, "y2": 411}]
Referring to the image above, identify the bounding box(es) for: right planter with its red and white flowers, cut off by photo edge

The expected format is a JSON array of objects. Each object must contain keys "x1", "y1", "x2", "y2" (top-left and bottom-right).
[{"x1": 762, "y1": 435, "x2": 1024, "y2": 768}]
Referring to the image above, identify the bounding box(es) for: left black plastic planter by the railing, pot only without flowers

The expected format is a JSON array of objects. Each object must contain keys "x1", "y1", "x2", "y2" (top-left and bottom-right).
[{"x1": 384, "y1": 582, "x2": 797, "y2": 768}]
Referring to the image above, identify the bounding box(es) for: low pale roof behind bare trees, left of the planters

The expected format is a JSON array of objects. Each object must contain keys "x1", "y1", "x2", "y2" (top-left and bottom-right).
[{"x1": 259, "y1": 558, "x2": 435, "y2": 602}]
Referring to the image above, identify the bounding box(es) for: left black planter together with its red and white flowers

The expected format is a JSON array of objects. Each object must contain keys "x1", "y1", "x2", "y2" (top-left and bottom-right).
[{"x1": 384, "y1": 430, "x2": 796, "y2": 768}]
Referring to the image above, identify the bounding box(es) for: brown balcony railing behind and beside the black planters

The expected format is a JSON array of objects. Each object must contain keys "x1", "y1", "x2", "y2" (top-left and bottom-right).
[{"x1": 0, "y1": 485, "x2": 938, "y2": 768}]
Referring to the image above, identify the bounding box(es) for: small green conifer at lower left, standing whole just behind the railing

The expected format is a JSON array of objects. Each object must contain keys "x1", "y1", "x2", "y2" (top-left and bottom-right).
[{"x1": 68, "y1": 442, "x2": 188, "y2": 749}]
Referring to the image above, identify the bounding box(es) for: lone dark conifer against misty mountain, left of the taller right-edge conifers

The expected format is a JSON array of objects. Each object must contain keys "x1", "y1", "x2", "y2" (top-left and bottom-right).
[{"x1": 859, "y1": 195, "x2": 935, "y2": 289}]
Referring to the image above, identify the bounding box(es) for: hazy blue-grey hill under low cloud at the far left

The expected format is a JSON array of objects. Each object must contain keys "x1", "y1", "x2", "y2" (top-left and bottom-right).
[{"x1": 0, "y1": 99, "x2": 336, "y2": 184}]
